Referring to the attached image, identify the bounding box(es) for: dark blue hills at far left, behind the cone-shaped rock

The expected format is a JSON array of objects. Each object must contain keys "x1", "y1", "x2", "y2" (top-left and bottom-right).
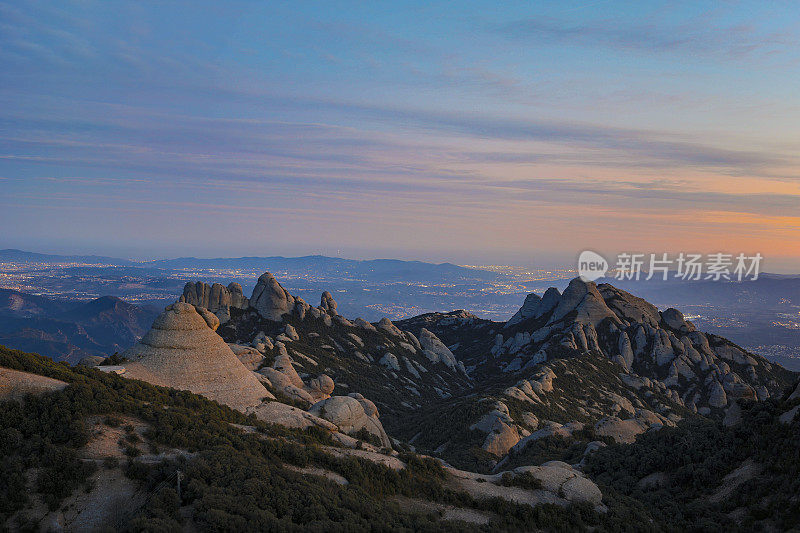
[{"x1": 0, "y1": 289, "x2": 156, "y2": 363}]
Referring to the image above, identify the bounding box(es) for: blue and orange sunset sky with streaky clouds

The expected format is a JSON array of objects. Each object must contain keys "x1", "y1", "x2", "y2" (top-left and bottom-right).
[{"x1": 0, "y1": 1, "x2": 800, "y2": 273}]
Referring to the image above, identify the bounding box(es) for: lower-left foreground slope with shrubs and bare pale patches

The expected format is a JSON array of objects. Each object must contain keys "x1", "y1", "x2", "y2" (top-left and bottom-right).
[{"x1": 0, "y1": 347, "x2": 648, "y2": 531}]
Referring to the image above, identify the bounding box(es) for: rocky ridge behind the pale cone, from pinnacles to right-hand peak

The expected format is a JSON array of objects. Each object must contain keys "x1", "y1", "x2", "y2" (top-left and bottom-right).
[{"x1": 172, "y1": 274, "x2": 796, "y2": 472}]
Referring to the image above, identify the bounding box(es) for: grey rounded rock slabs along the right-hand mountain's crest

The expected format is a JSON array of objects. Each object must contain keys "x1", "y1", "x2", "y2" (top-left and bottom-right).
[{"x1": 489, "y1": 278, "x2": 785, "y2": 414}]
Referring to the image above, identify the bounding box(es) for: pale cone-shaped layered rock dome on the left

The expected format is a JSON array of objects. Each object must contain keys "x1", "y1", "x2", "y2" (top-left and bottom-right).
[{"x1": 121, "y1": 302, "x2": 272, "y2": 412}]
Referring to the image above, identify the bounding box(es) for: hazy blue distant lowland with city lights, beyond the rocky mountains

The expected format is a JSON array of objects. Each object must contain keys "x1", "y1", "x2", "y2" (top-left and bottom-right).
[{"x1": 0, "y1": 250, "x2": 800, "y2": 370}]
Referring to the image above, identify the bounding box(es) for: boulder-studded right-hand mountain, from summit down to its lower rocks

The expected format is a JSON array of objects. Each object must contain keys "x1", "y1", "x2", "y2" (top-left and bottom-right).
[{"x1": 398, "y1": 279, "x2": 796, "y2": 468}]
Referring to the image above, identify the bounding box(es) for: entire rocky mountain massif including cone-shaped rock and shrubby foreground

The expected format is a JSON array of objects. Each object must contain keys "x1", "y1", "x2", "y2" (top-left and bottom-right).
[{"x1": 0, "y1": 266, "x2": 800, "y2": 531}]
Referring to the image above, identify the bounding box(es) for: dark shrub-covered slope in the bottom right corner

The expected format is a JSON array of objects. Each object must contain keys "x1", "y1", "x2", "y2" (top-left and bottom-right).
[{"x1": 586, "y1": 384, "x2": 800, "y2": 531}]
